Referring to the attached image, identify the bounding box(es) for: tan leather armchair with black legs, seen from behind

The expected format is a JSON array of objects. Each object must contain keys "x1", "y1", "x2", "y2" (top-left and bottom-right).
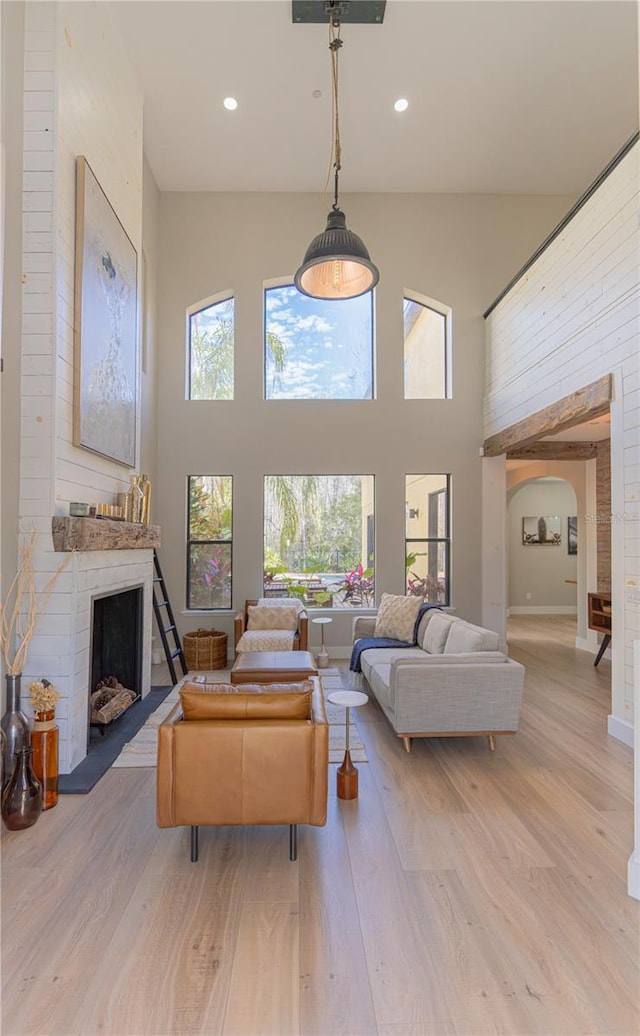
[{"x1": 156, "y1": 678, "x2": 328, "y2": 862}]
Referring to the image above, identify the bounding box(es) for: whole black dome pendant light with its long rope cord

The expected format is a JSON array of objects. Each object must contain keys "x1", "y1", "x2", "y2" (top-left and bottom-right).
[{"x1": 294, "y1": 18, "x2": 380, "y2": 298}]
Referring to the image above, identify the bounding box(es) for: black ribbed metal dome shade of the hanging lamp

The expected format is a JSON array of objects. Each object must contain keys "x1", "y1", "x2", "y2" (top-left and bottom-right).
[{"x1": 294, "y1": 208, "x2": 380, "y2": 298}]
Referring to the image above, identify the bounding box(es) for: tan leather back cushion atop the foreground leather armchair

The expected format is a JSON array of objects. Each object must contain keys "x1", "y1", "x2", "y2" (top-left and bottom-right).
[{"x1": 180, "y1": 681, "x2": 313, "y2": 720}]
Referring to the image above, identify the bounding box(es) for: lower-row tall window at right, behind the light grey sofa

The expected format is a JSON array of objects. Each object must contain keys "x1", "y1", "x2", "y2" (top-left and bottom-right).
[{"x1": 405, "y1": 474, "x2": 450, "y2": 604}]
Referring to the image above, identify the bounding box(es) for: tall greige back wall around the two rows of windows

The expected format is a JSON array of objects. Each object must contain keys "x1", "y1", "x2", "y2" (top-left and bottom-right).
[{"x1": 154, "y1": 193, "x2": 571, "y2": 645}]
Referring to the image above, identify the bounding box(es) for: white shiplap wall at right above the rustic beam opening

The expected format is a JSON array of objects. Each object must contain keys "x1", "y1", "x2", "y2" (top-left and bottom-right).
[{"x1": 485, "y1": 144, "x2": 640, "y2": 743}]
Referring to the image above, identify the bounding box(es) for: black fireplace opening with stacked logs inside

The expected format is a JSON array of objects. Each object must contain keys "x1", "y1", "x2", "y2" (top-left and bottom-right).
[{"x1": 87, "y1": 585, "x2": 144, "y2": 749}]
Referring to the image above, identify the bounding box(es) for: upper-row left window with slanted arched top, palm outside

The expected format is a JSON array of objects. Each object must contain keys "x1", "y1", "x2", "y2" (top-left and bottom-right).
[{"x1": 188, "y1": 298, "x2": 234, "y2": 399}]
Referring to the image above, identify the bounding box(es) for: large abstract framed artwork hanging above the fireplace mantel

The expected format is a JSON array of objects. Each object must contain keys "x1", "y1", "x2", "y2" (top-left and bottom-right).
[{"x1": 74, "y1": 155, "x2": 138, "y2": 467}]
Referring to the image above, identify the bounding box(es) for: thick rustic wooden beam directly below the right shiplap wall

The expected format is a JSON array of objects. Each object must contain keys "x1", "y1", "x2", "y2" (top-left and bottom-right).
[{"x1": 485, "y1": 374, "x2": 613, "y2": 457}]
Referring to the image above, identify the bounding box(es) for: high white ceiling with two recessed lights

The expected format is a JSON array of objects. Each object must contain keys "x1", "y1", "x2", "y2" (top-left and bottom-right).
[{"x1": 111, "y1": 0, "x2": 638, "y2": 195}]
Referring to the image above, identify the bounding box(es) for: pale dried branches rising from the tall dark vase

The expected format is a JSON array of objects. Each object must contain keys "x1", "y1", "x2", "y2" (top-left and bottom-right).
[{"x1": 0, "y1": 533, "x2": 71, "y2": 675}]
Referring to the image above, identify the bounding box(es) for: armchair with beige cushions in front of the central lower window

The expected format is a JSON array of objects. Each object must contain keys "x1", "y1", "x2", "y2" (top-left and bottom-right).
[{"x1": 233, "y1": 597, "x2": 309, "y2": 658}]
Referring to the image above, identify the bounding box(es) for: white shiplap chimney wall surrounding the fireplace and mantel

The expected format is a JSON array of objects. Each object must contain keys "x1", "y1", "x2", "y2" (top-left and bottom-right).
[{"x1": 20, "y1": 2, "x2": 152, "y2": 773}]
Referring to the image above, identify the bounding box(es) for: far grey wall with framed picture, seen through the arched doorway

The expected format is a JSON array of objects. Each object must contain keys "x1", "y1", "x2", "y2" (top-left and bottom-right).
[{"x1": 507, "y1": 479, "x2": 578, "y2": 613}]
